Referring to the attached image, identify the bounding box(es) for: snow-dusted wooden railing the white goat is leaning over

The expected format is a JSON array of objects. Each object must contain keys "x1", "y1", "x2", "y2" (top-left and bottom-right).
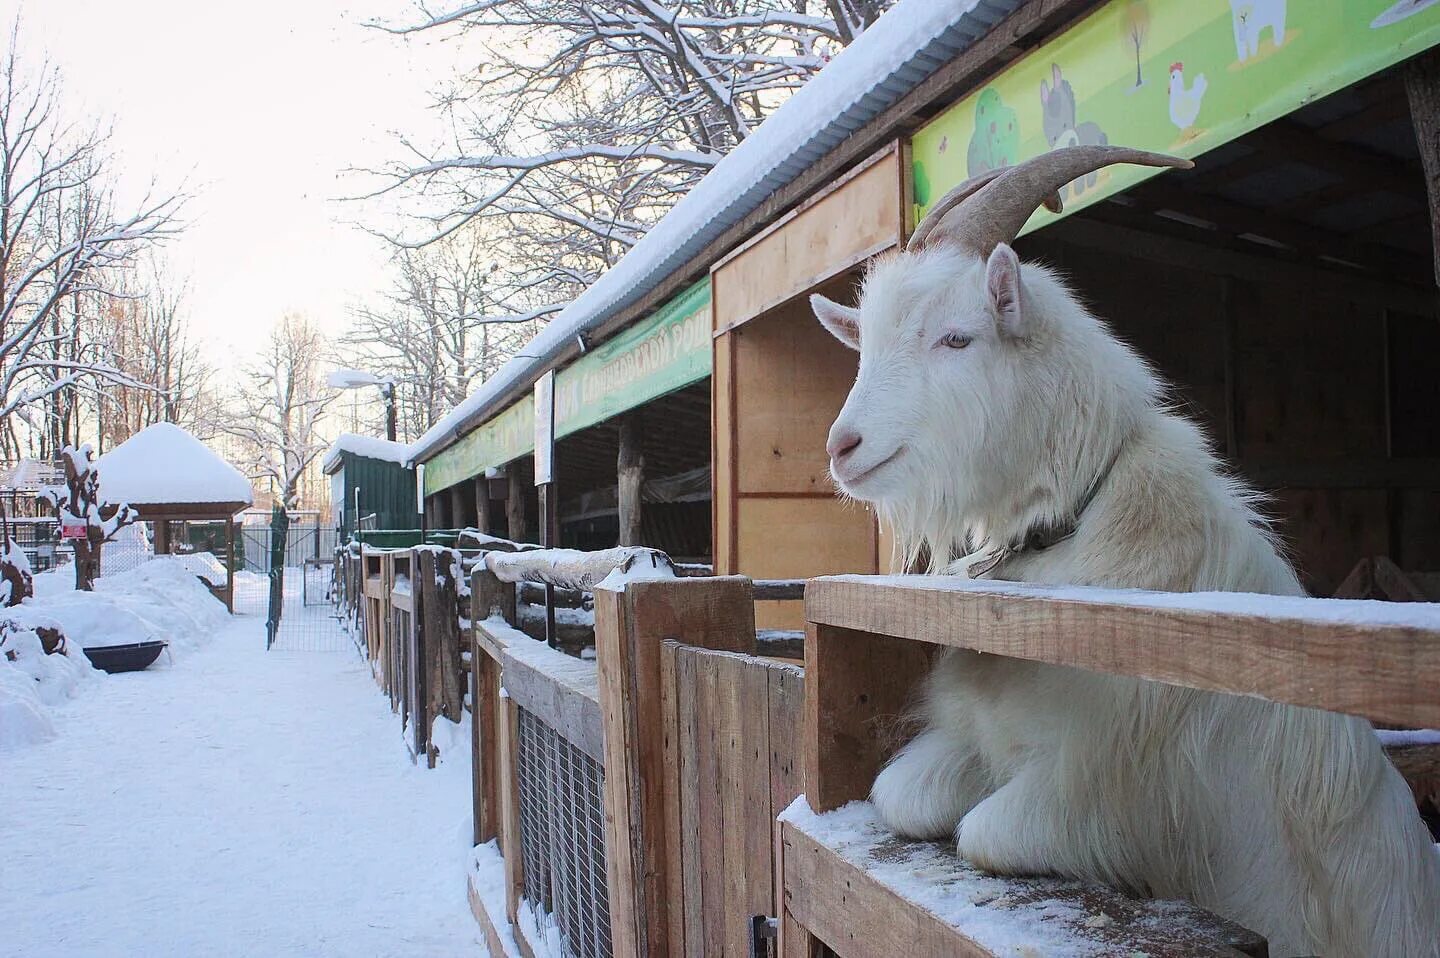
[{"x1": 779, "y1": 576, "x2": 1440, "y2": 957}]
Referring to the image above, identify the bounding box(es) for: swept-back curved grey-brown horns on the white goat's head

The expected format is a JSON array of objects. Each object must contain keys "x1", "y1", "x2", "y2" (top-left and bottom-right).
[{"x1": 907, "y1": 146, "x2": 1195, "y2": 256}]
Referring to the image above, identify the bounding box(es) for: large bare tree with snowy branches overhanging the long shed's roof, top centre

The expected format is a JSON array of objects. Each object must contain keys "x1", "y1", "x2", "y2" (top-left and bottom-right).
[{"x1": 362, "y1": 0, "x2": 890, "y2": 278}]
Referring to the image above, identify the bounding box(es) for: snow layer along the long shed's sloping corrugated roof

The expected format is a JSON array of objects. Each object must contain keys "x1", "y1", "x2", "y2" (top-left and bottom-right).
[{"x1": 409, "y1": 0, "x2": 1020, "y2": 460}]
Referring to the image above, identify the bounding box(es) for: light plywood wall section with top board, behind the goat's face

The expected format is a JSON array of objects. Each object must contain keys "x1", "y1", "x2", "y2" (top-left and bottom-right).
[{"x1": 711, "y1": 147, "x2": 904, "y2": 630}]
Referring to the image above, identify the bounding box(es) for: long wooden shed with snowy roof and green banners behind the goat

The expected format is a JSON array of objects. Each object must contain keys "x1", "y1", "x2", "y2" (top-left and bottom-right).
[{"x1": 416, "y1": 0, "x2": 1440, "y2": 613}]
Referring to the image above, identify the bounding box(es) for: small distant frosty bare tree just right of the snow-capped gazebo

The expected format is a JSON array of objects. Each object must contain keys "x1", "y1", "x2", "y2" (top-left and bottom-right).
[{"x1": 219, "y1": 313, "x2": 338, "y2": 510}]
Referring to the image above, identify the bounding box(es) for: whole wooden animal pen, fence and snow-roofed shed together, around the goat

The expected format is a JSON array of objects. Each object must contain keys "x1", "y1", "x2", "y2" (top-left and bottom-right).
[{"x1": 344, "y1": 0, "x2": 1440, "y2": 957}]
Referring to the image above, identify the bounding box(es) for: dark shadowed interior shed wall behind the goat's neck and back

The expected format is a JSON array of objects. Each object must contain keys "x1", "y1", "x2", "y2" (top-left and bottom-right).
[{"x1": 1021, "y1": 224, "x2": 1440, "y2": 595}]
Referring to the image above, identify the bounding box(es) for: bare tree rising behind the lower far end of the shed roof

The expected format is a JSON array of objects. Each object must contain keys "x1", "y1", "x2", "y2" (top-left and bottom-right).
[{"x1": 343, "y1": 226, "x2": 557, "y2": 441}]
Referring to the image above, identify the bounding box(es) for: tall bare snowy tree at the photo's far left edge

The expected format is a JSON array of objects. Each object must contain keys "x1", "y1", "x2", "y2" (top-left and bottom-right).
[{"x1": 0, "y1": 24, "x2": 181, "y2": 455}]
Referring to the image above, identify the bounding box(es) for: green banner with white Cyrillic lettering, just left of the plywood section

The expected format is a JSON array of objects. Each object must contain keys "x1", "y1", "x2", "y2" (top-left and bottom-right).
[{"x1": 554, "y1": 278, "x2": 711, "y2": 438}]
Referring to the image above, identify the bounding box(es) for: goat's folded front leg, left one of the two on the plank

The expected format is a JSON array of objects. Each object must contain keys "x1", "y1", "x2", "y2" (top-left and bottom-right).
[{"x1": 870, "y1": 728, "x2": 995, "y2": 838}]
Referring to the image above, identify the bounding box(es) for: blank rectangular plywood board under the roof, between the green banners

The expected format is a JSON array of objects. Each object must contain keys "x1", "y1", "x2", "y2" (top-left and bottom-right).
[{"x1": 711, "y1": 145, "x2": 903, "y2": 330}]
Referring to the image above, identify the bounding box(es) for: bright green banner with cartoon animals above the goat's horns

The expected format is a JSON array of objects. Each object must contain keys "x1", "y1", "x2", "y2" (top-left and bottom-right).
[{"x1": 913, "y1": 0, "x2": 1440, "y2": 230}]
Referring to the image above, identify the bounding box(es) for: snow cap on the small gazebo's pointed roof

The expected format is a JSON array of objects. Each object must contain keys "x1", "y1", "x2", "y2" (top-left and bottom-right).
[{"x1": 95, "y1": 422, "x2": 253, "y2": 506}]
